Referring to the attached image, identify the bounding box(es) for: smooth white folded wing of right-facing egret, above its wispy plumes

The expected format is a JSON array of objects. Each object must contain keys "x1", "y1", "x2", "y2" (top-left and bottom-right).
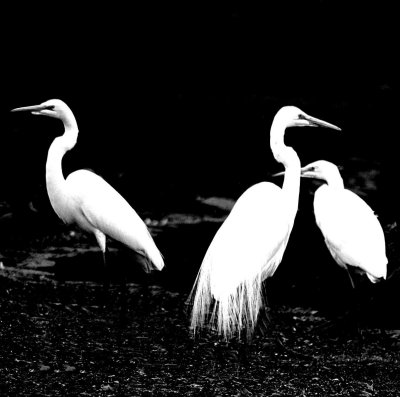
[{"x1": 204, "y1": 183, "x2": 292, "y2": 297}]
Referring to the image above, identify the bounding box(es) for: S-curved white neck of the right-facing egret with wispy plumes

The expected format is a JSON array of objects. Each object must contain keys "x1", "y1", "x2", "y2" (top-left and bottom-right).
[{"x1": 270, "y1": 119, "x2": 301, "y2": 219}]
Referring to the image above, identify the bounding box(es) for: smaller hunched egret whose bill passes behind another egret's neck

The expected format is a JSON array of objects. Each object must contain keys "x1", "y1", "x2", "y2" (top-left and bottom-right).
[{"x1": 301, "y1": 160, "x2": 388, "y2": 287}]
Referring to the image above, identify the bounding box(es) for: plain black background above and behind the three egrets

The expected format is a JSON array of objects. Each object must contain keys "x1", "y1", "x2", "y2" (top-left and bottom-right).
[{"x1": 0, "y1": 0, "x2": 399, "y2": 276}]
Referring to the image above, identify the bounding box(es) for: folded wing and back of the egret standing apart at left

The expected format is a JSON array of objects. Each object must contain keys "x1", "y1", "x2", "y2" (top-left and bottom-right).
[{"x1": 66, "y1": 170, "x2": 164, "y2": 270}]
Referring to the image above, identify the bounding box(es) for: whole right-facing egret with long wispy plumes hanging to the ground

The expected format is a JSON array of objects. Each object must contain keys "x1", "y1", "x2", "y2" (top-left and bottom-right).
[{"x1": 189, "y1": 106, "x2": 340, "y2": 340}]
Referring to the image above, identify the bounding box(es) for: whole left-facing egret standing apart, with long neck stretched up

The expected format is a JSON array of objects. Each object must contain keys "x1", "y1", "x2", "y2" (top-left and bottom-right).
[{"x1": 12, "y1": 99, "x2": 164, "y2": 271}]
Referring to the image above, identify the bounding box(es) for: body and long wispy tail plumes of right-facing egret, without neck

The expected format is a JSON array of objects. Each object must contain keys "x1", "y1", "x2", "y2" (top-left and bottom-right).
[{"x1": 191, "y1": 182, "x2": 293, "y2": 337}]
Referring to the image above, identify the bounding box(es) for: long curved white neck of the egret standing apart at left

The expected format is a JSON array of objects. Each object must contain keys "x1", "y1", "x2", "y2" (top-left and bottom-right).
[{"x1": 46, "y1": 116, "x2": 79, "y2": 220}]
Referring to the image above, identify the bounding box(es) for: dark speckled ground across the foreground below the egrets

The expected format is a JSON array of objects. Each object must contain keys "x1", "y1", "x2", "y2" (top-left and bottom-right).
[{"x1": 0, "y1": 270, "x2": 400, "y2": 396}]
